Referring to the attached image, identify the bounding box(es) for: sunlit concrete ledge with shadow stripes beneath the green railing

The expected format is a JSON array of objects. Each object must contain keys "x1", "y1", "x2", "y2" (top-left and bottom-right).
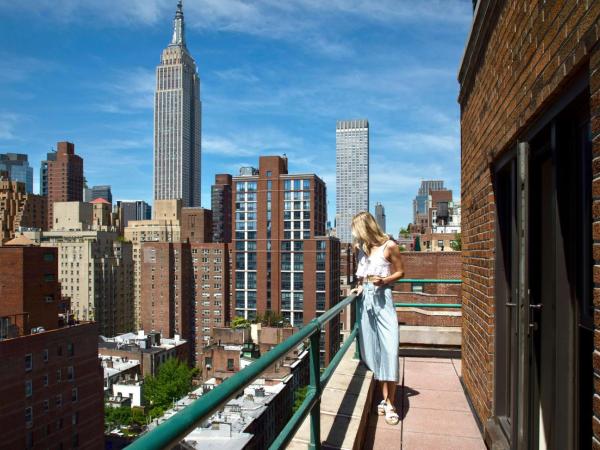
[{"x1": 287, "y1": 343, "x2": 375, "y2": 450}]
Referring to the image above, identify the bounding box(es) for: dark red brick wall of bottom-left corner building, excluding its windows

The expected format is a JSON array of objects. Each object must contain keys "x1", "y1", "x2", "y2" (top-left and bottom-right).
[{"x1": 0, "y1": 323, "x2": 104, "y2": 449}]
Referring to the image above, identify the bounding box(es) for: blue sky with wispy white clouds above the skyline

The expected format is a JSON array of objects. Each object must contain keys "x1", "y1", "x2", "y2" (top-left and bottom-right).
[{"x1": 0, "y1": 0, "x2": 471, "y2": 234}]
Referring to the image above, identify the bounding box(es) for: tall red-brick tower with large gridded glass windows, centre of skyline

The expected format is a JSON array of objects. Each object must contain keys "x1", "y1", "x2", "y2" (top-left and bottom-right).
[{"x1": 232, "y1": 156, "x2": 340, "y2": 361}]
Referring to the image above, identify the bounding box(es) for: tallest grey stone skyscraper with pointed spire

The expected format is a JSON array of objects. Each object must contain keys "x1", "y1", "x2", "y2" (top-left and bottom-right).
[{"x1": 154, "y1": 0, "x2": 201, "y2": 207}]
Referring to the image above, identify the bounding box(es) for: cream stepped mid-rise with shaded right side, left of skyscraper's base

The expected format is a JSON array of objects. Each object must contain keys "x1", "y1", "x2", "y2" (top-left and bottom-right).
[{"x1": 24, "y1": 202, "x2": 134, "y2": 336}]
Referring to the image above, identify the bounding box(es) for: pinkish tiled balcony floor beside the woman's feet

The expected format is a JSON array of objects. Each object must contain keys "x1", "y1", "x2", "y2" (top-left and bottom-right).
[{"x1": 364, "y1": 357, "x2": 486, "y2": 450}]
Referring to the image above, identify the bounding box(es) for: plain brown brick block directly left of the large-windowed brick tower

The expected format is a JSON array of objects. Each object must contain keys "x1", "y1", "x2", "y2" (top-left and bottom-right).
[{"x1": 141, "y1": 242, "x2": 230, "y2": 365}]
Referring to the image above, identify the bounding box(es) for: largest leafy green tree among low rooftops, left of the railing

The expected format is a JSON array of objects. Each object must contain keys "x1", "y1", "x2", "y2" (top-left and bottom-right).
[{"x1": 144, "y1": 358, "x2": 197, "y2": 417}]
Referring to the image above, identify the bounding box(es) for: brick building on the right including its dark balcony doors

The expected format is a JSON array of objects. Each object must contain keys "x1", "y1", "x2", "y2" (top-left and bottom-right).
[{"x1": 459, "y1": 0, "x2": 600, "y2": 449}]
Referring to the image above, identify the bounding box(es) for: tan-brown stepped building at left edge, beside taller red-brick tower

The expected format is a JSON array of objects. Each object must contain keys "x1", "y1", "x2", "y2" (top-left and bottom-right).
[{"x1": 0, "y1": 171, "x2": 48, "y2": 244}]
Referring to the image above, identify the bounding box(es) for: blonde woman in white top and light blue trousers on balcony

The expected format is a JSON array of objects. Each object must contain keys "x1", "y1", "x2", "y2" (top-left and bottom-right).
[{"x1": 352, "y1": 212, "x2": 404, "y2": 425}]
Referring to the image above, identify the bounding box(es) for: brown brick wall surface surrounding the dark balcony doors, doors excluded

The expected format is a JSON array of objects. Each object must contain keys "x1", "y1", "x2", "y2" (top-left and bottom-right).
[{"x1": 459, "y1": 0, "x2": 600, "y2": 438}]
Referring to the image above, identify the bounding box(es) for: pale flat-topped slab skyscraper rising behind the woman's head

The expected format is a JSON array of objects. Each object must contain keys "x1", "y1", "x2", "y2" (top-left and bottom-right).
[{"x1": 335, "y1": 119, "x2": 369, "y2": 242}]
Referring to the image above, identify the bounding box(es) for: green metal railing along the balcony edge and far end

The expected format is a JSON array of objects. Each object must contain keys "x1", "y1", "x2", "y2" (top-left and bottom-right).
[{"x1": 127, "y1": 279, "x2": 461, "y2": 450}]
